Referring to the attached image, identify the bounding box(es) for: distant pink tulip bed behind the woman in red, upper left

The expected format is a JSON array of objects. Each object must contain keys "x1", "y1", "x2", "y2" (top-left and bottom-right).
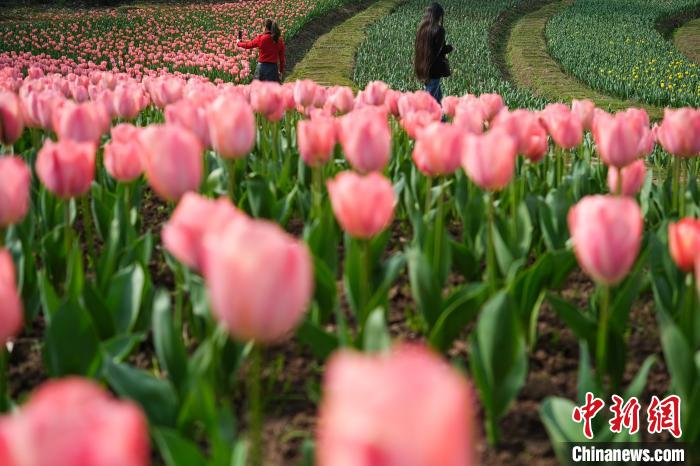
[{"x1": 0, "y1": 0, "x2": 344, "y2": 83}]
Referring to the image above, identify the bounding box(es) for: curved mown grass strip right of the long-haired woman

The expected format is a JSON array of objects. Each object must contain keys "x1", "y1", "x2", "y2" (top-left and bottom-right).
[{"x1": 506, "y1": 1, "x2": 663, "y2": 119}]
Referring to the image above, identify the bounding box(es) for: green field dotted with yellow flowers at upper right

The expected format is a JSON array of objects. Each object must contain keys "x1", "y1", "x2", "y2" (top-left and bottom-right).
[{"x1": 546, "y1": 0, "x2": 700, "y2": 107}]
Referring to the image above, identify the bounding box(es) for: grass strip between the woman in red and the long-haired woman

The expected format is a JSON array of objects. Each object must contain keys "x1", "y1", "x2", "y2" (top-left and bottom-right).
[{"x1": 287, "y1": 0, "x2": 404, "y2": 87}]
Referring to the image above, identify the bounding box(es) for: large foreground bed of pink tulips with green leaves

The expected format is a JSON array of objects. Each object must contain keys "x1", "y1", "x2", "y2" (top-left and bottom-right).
[{"x1": 0, "y1": 73, "x2": 700, "y2": 466}]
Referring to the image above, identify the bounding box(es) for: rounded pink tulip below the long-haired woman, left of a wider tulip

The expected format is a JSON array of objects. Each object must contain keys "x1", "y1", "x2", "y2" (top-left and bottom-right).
[{"x1": 413, "y1": 123, "x2": 464, "y2": 176}]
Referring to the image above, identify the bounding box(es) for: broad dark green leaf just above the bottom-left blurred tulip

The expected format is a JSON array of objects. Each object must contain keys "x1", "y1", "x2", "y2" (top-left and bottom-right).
[{"x1": 44, "y1": 301, "x2": 100, "y2": 377}]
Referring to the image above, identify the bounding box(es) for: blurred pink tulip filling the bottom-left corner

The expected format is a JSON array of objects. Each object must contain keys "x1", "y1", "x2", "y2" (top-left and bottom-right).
[{"x1": 0, "y1": 377, "x2": 150, "y2": 466}]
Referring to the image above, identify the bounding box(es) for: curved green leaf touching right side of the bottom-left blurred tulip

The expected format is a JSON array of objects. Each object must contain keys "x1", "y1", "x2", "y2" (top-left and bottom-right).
[{"x1": 103, "y1": 359, "x2": 178, "y2": 426}]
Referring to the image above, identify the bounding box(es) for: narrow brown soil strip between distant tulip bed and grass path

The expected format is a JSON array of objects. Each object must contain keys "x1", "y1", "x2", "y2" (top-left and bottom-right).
[{"x1": 287, "y1": 0, "x2": 376, "y2": 81}]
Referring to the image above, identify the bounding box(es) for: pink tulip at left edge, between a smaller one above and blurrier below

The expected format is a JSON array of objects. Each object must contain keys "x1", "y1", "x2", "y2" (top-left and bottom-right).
[{"x1": 0, "y1": 157, "x2": 32, "y2": 229}]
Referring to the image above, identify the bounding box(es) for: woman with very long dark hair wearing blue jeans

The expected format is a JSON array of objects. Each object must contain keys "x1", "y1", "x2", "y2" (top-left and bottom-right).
[{"x1": 414, "y1": 2, "x2": 453, "y2": 103}]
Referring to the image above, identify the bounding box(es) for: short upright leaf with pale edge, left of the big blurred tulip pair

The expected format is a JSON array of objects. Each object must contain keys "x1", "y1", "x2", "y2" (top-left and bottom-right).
[{"x1": 106, "y1": 264, "x2": 146, "y2": 333}]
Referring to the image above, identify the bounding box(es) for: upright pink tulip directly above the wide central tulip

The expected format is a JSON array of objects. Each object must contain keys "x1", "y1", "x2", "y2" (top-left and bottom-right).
[{"x1": 339, "y1": 108, "x2": 391, "y2": 173}]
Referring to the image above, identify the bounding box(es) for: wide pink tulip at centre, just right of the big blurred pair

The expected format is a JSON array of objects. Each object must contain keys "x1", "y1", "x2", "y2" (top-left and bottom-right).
[{"x1": 326, "y1": 171, "x2": 397, "y2": 239}]
